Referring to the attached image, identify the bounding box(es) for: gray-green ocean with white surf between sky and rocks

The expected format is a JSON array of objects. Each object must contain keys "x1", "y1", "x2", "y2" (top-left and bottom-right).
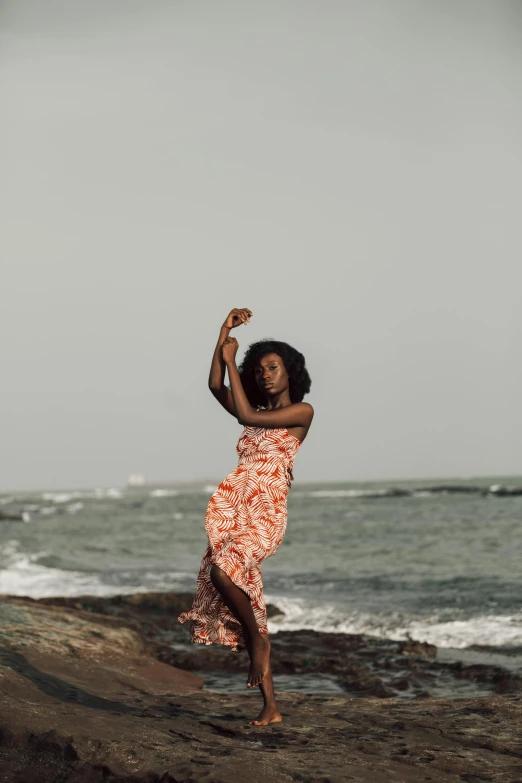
[{"x1": 0, "y1": 476, "x2": 522, "y2": 659}]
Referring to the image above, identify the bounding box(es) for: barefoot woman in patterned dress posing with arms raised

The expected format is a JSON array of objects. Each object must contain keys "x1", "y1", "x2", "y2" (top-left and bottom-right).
[{"x1": 178, "y1": 308, "x2": 314, "y2": 726}]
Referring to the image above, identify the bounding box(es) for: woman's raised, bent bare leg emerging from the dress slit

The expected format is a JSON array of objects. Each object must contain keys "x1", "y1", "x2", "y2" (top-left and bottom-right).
[{"x1": 210, "y1": 563, "x2": 270, "y2": 688}]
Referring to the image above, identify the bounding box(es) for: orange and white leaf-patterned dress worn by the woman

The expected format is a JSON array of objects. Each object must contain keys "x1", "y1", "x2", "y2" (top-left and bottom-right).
[{"x1": 178, "y1": 427, "x2": 301, "y2": 651}]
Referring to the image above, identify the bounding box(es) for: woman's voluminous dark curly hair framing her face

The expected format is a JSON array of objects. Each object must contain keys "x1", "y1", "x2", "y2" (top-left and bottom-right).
[{"x1": 239, "y1": 337, "x2": 312, "y2": 406}]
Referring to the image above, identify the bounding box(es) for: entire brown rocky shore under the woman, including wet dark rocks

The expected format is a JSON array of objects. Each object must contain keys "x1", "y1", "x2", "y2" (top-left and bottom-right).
[{"x1": 0, "y1": 593, "x2": 522, "y2": 783}]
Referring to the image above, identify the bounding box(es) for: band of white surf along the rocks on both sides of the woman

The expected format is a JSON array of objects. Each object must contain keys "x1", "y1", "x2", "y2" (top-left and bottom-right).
[{"x1": 0, "y1": 539, "x2": 522, "y2": 649}]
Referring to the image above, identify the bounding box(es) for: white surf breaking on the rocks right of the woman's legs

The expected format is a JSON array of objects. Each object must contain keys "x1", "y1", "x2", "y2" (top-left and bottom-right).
[{"x1": 266, "y1": 595, "x2": 522, "y2": 649}]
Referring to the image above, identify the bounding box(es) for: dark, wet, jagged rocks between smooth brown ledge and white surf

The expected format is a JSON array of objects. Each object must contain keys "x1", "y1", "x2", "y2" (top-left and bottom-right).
[{"x1": 33, "y1": 593, "x2": 522, "y2": 698}]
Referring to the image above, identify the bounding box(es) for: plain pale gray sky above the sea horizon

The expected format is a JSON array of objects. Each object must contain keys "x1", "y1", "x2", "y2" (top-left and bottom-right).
[{"x1": 0, "y1": 0, "x2": 522, "y2": 490}]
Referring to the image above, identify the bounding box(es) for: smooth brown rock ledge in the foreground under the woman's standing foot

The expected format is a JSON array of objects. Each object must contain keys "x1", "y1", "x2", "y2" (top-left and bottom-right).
[{"x1": 0, "y1": 596, "x2": 522, "y2": 783}]
